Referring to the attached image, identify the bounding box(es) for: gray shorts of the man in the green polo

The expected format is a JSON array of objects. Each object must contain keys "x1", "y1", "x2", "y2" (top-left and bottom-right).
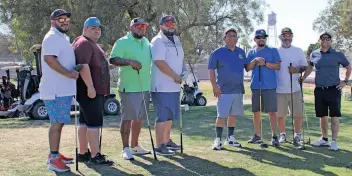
[{"x1": 119, "y1": 91, "x2": 150, "y2": 120}]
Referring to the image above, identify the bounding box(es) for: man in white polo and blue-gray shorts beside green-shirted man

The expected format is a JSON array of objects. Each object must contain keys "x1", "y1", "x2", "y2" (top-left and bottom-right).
[{"x1": 151, "y1": 15, "x2": 187, "y2": 155}]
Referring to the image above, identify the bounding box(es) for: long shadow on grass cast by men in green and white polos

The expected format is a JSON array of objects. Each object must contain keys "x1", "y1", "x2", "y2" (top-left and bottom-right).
[{"x1": 131, "y1": 154, "x2": 254, "y2": 176}]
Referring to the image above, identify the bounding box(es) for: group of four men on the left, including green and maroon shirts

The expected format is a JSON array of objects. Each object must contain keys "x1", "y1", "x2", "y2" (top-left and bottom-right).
[{"x1": 40, "y1": 9, "x2": 187, "y2": 172}]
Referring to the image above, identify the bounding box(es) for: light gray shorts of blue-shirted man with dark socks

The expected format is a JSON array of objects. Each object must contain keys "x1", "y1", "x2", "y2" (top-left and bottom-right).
[{"x1": 216, "y1": 93, "x2": 244, "y2": 118}]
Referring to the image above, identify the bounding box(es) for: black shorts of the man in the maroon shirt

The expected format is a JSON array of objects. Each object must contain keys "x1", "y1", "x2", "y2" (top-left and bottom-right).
[{"x1": 77, "y1": 94, "x2": 104, "y2": 128}]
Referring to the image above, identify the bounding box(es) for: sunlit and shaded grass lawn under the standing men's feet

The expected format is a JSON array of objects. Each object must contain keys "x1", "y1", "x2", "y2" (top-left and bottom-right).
[{"x1": 0, "y1": 82, "x2": 352, "y2": 176}]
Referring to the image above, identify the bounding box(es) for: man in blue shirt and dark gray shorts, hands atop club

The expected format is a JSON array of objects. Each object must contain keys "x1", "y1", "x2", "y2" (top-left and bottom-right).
[{"x1": 246, "y1": 29, "x2": 281, "y2": 147}]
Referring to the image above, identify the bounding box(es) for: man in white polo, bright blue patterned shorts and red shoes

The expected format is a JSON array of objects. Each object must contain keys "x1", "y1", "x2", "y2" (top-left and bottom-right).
[{"x1": 39, "y1": 9, "x2": 79, "y2": 172}]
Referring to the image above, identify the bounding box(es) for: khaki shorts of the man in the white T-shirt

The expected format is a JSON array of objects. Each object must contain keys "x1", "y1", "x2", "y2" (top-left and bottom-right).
[{"x1": 276, "y1": 91, "x2": 303, "y2": 117}]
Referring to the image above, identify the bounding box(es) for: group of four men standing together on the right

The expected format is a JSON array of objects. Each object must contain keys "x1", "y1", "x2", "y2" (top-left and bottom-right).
[{"x1": 208, "y1": 27, "x2": 351, "y2": 151}]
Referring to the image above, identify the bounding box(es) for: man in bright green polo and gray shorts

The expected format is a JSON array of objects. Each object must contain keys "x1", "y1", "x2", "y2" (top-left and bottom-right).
[{"x1": 110, "y1": 18, "x2": 152, "y2": 160}]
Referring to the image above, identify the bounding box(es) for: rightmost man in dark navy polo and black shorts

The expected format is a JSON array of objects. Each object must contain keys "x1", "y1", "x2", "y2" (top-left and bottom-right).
[{"x1": 301, "y1": 32, "x2": 351, "y2": 151}]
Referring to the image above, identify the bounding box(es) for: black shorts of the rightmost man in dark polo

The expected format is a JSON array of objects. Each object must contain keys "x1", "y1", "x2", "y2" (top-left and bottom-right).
[{"x1": 314, "y1": 86, "x2": 341, "y2": 117}]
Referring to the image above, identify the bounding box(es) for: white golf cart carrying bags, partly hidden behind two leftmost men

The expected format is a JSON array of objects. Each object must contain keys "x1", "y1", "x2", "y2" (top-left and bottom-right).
[{"x1": 9, "y1": 44, "x2": 120, "y2": 120}]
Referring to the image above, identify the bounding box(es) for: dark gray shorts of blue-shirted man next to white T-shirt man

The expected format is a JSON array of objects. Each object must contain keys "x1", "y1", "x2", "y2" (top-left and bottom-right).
[{"x1": 252, "y1": 89, "x2": 277, "y2": 113}]
